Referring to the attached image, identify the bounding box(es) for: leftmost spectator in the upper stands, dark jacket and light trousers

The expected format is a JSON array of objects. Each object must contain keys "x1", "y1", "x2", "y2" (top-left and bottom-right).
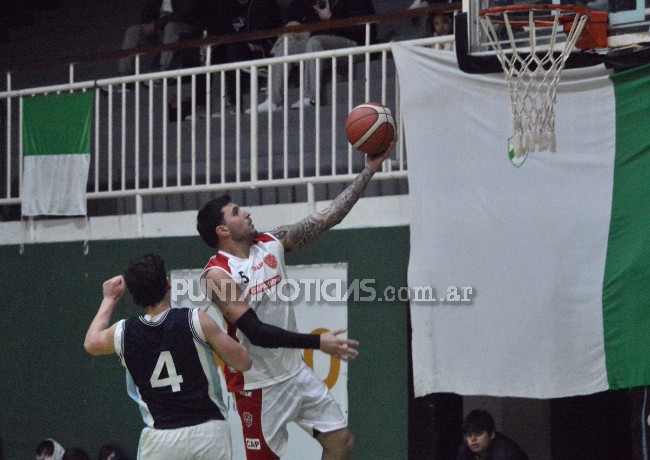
[{"x1": 119, "y1": 0, "x2": 207, "y2": 80}]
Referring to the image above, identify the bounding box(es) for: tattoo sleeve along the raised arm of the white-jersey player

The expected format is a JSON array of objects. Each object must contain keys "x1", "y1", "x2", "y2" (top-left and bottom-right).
[{"x1": 284, "y1": 168, "x2": 373, "y2": 250}]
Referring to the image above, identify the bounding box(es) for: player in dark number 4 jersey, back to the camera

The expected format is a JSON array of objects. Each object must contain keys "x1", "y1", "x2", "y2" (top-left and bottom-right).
[{"x1": 84, "y1": 254, "x2": 251, "y2": 460}]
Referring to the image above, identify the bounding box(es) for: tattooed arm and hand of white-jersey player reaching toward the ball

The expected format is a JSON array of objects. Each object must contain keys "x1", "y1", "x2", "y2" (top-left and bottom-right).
[{"x1": 270, "y1": 142, "x2": 395, "y2": 252}]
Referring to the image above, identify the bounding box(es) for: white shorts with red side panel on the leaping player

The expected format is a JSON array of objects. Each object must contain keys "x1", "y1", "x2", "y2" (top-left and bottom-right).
[{"x1": 235, "y1": 366, "x2": 347, "y2": 460}]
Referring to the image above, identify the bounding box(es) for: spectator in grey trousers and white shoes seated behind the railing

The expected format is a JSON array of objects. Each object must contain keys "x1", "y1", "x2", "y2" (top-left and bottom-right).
[{"x1": 252, "y1": 0, "x2": 375, "y2": 112}]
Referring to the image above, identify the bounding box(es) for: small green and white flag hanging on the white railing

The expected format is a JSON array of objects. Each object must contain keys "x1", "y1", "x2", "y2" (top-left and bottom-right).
[{"x1": 21, "y1": 92, "x2": 94, "y2": 216}]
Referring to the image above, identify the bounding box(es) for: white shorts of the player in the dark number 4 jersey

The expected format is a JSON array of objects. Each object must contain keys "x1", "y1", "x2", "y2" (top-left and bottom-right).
[{"x1": 138, "y1": 420, "x2": 232, "y2": 460}]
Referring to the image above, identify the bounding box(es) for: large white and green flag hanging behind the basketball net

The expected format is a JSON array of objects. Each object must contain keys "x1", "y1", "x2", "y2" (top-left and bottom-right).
[{"x1": 393, "y1": 44, "x2": 650, "y2": 398}]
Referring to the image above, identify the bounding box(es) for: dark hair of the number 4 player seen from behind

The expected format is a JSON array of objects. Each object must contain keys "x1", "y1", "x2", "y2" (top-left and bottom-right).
[{"x1": 123, "y1": 254, "x2": 167, "y2": 308}]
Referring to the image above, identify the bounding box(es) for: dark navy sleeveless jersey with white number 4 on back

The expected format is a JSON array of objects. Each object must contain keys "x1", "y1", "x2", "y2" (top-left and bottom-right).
[{"x1": 115, "y1": 308, "x2": 226, "y2": 429}]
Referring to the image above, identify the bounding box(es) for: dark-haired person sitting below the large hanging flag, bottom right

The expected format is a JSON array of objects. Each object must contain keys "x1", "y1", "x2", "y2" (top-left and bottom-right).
[{"x1": 456, "y1": 409, "x2": 528, "y2": 460}]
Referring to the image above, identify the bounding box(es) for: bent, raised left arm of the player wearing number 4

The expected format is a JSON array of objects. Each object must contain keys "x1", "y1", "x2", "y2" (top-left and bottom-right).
[{"x1": 84, "y1": 275, "x2": 126, "y2": 356}]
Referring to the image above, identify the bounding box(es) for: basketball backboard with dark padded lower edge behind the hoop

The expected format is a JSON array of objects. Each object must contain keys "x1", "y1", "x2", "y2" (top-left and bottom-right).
[{"x1": 455, "y1": 0, "x2": 650, "y2": 73}]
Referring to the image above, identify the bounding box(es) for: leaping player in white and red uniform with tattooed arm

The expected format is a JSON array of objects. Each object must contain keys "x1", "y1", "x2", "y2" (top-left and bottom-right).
[{"x1": 197, "y1": 145, "x2": 393, "y2": 460}]
